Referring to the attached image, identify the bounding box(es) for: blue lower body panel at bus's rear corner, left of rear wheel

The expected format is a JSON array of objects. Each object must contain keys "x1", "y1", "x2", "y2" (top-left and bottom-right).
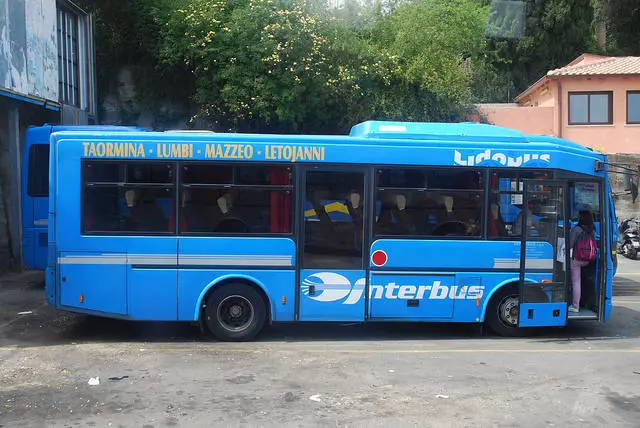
[{"x1": 58, "y1": 253, "x2": 127, "y2": 315}]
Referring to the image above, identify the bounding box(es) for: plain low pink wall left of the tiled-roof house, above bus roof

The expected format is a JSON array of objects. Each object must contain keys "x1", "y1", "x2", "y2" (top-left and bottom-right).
[{"x1": 476, "y1": 104, "x2": 554, "y2": 135}]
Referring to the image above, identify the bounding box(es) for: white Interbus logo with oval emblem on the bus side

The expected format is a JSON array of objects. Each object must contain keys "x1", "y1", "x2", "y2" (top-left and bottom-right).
[{"x1": 302, "y1": 272, "x2": 484, "y2": 305}]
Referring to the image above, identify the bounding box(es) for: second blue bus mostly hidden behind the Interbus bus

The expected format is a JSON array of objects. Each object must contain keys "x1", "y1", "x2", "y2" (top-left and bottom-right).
[{"x1": 21, "y1": 125, "x2": 142, "y2": 270}]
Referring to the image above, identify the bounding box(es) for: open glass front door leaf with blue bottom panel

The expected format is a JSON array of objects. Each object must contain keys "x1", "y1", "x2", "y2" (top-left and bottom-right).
[{"x1": 517, "y1": 180, "x2": 569, "y2": 327}]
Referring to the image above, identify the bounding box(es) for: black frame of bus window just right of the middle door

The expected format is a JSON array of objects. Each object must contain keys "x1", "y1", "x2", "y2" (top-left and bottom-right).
[{"x1": 368, "y1": 165, "x2": 489, "y2": 243}]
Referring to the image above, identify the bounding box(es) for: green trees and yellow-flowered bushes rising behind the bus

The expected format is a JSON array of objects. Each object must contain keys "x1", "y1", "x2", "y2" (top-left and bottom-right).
[{"x1": 81, "y1": 0, "x2": 640, "y2": 133}]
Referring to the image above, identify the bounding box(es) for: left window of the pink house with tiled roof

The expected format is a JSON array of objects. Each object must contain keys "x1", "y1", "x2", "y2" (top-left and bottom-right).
[{"x1": 569, "y1": 92, "x2": 613, "y2": 125}]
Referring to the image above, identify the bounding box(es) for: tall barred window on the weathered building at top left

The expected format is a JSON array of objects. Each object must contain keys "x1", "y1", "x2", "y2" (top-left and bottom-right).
[{"x1": 56, "y1": 0, "x2": 95, "y2": 112}]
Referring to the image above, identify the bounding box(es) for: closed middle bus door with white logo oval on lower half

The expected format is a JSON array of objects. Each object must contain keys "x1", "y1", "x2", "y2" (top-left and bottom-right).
[{"x1": 297, "y1": 167, "x2": 371, "y2": 321}]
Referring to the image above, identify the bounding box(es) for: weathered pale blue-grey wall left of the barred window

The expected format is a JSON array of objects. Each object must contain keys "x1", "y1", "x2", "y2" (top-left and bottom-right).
[{"x1": 0, "y1": 0, "x2": 58, "y2": 102}]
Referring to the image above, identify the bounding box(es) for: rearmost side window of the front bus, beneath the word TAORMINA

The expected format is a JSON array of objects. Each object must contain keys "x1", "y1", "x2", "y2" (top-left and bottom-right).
[{"x1": 82, "y1": 161, "x2": 175, "y2": 234}]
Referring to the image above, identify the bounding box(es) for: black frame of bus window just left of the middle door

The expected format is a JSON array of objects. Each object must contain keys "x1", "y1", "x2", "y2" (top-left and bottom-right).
[{"x1": 176, "y1": 160, "x2": 297, "y2": 238}]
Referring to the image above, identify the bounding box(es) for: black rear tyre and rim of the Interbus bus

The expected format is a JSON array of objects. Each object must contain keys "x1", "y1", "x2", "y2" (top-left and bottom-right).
[{"x1": 204, "y1": 282, "x2": 267, "y2": 342}]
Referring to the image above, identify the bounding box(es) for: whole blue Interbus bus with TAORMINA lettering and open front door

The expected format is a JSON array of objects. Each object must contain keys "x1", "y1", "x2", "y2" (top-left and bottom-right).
[{"x1": 46, "y1": 121, "x2": 615, "y2": 341}]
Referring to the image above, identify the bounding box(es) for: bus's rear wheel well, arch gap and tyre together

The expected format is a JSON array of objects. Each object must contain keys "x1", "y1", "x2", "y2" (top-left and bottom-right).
[{"x1": 199, "y1": 276, "x2": 272, "y2": 341}]
